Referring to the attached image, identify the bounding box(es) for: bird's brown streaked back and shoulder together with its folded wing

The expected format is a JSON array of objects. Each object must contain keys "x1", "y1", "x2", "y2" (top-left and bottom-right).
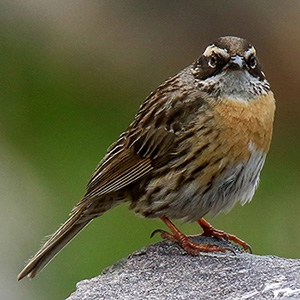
[{"x1": 75, "y1": 70, "x2": 204, "y2": 205}]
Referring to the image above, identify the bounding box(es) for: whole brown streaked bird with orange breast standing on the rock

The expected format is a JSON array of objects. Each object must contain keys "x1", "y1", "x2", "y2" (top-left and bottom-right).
[{"x1": 18, "y1": 36, "x2": 275, "y2": 280}]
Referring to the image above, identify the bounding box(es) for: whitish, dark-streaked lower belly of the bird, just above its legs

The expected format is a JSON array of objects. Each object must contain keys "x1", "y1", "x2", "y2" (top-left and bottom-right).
[{"x1": 136, "y1": 143, "x2": 266, "y2": 221}]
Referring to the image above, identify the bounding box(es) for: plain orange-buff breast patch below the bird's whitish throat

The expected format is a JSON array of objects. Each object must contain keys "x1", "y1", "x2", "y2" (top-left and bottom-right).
[{"x1": 214, "y1": 91, "x2": 275, "y2": 161}]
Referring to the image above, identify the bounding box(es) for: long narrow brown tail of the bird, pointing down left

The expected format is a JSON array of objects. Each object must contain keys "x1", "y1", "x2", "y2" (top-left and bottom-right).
[{"x1": 18, "y1": 211, "x2": 93, "y2": 280}]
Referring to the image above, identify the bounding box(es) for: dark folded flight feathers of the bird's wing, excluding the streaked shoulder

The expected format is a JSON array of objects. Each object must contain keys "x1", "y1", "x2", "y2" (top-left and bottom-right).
[{"x1": 79, "y1": 123, "x2": 175, "y2": 202}]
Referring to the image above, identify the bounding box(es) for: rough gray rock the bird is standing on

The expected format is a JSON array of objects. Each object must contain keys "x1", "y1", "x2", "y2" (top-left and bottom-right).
[{"x1": 67, "y1": 237, "x2": 300, "y2": 300}]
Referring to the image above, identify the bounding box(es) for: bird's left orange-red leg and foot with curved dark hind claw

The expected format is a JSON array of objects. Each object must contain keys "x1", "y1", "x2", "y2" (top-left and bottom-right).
[{"x1": 151, "y1": 216, "x2": 232, "y2": 255}]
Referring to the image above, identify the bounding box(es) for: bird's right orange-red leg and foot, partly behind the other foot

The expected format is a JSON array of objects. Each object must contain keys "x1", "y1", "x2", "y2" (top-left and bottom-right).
[{"x1": 197, "y1": 218, "x2": 252, "y2": 253}]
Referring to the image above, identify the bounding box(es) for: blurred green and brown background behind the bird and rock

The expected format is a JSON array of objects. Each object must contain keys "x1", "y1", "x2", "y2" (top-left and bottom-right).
[{"x1": 0, "y1": 0, "x2": 300, "y2": 300}]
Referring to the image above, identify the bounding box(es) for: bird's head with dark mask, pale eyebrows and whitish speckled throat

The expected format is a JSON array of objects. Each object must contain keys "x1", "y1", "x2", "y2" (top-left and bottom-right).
[{"x1": 192, "y1": 36, "x2": 269, "y2": 101}]
